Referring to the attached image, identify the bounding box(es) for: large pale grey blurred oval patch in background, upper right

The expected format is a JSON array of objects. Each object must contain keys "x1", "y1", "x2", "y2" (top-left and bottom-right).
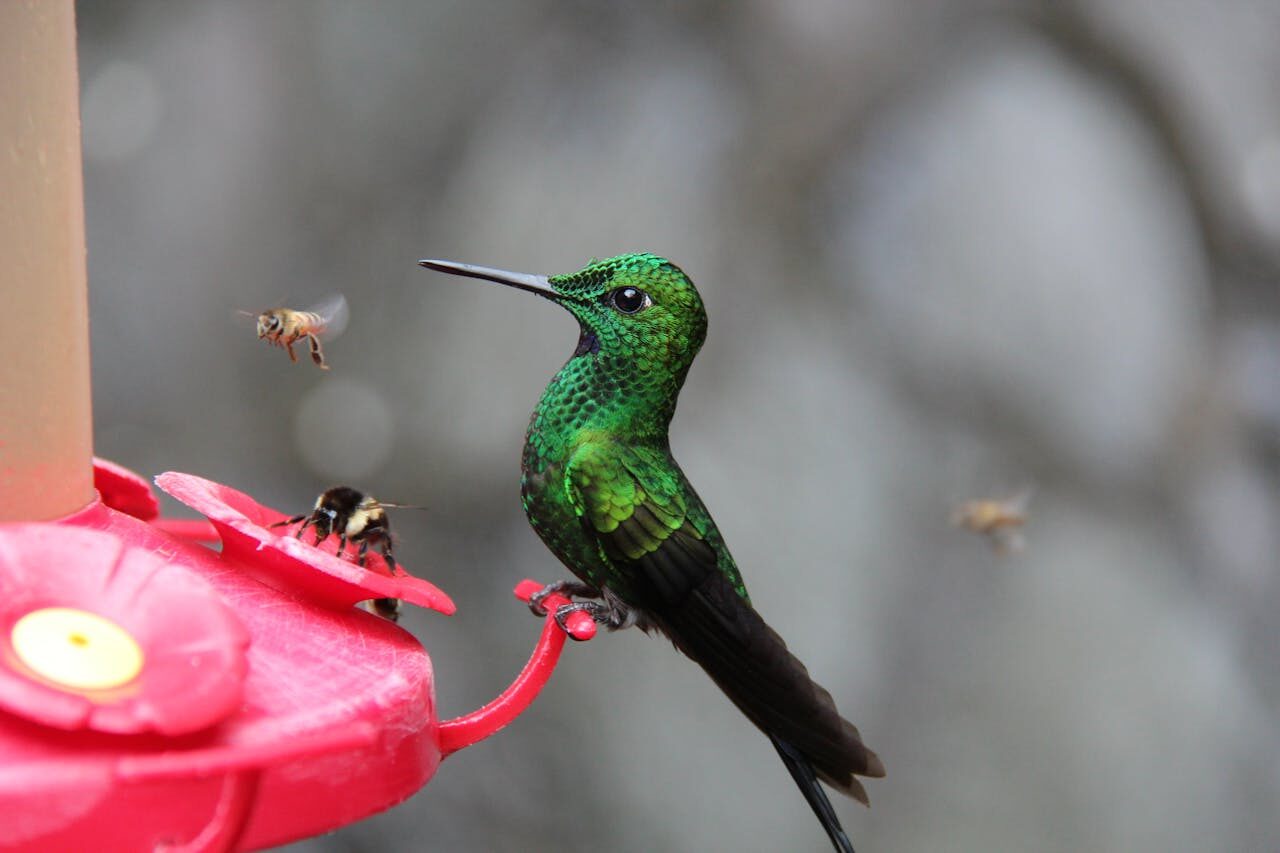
[{"x1": 831, "y1": 29, "x2": 1207, "y2": 484}]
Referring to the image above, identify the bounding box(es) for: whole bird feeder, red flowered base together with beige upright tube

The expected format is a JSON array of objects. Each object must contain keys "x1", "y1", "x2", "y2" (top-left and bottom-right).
[{"x1": 0, "y1": 3, "x2": 595, "y2": 853}]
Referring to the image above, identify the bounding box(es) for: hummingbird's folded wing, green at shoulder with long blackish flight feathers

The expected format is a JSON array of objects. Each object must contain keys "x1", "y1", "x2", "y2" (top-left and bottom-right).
[{"x1": 566, "y1": 444, "x2": 884, "y2": 817}]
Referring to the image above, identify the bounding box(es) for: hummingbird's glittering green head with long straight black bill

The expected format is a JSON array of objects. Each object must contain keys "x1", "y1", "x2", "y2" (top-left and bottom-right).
[{"x1": 419, "y1": 249, "x2": 707, "y2": 368}]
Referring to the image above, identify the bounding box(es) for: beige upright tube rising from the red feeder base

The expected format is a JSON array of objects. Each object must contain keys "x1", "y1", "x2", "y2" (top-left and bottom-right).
[{"x1": 0, "y1": 0, "x2": 93, "y2": 521}]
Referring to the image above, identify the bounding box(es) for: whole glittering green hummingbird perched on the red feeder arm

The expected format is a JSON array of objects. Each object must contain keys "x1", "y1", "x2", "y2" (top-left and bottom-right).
[{"x1": 419, "y1": 254, "x2": 884, "y2": 853}]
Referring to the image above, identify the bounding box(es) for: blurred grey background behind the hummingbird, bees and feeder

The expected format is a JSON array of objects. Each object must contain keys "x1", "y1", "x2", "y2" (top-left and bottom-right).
[{"x1": 79, "y1": 0, "x2": 1280, "y2": 853}]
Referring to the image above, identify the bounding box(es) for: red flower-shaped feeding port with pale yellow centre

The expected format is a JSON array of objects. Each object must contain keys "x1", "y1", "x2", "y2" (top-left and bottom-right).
[{"x1": 0, "y1": 525, "x2": 248, "y2": 735}]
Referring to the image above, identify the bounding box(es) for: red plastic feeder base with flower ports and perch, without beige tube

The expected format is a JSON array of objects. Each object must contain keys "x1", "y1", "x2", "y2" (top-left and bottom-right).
[{"x1": 0, "y1": 460, "x2": 595, "y2": 853}]
